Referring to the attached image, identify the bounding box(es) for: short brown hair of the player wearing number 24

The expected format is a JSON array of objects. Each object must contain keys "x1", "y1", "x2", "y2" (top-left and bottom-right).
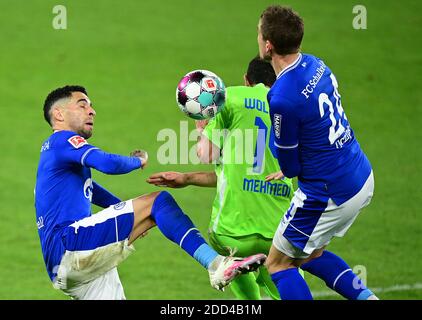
[{"x1": 261, "y1": 5, "x2": 304, "y2": 55}]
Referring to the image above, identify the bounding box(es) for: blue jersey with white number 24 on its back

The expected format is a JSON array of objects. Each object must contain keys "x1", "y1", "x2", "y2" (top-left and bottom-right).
[{"x1": 268, "y1": 54, "x2": 371, "y2": 205}]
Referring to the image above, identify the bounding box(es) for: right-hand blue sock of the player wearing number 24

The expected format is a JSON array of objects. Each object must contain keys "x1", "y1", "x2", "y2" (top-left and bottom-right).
[{"x1": 301, "y1": 251, "x2": 373, "y2": 300}]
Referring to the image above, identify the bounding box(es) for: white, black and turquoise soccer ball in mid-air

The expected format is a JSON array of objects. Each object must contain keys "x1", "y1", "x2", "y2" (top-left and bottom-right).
[{"x1": 176, "y1": 70, "x2": 226, "y2": 120}]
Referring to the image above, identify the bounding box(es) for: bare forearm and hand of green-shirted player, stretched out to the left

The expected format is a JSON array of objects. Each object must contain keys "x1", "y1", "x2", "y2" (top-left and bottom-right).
[{"x1": 147, "y1": 171, "x2": 217, "y2": 188}]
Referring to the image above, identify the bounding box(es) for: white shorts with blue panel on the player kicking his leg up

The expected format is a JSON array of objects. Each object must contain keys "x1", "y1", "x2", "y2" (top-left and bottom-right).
[{"x1": 53, "y1": 200, "x2": 135, "y2": 300}]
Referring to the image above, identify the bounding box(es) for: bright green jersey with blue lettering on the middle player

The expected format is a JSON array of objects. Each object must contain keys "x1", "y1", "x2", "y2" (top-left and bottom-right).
[{"x1": 203, "y1": 84, "x2": 293, "y2": 238}]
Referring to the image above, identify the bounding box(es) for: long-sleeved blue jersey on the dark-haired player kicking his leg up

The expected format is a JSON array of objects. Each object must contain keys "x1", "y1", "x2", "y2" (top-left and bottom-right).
[{"x1": 35, "y1": 131, "x2": 141, "y2": 279}]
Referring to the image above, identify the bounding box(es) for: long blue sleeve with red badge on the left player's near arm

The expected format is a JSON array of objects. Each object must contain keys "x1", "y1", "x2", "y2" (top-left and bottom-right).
[{"x1": 57, "y1": 132, "x2": 141, "y2": 174}]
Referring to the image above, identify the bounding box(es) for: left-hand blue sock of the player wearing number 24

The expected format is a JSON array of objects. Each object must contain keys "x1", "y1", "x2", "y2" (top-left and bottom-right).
[{"x1": 271, "y1": 268, "x2": 312, "y2": 300}]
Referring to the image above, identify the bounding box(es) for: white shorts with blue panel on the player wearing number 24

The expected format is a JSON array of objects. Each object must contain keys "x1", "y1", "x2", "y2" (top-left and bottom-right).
[{"x1": 273, "y1": 172, "x2": 374, "y2": 259}]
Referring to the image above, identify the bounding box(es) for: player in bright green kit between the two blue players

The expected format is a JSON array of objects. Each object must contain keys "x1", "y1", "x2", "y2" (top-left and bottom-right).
[{"x1": 147, "y1": 58, "x2": 300, "y2": 300}]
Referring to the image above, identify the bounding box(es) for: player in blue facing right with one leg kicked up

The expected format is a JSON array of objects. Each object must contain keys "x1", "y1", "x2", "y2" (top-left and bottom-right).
[{"x1": 35, "y1": 86, "x2": 266, "y2": 299}]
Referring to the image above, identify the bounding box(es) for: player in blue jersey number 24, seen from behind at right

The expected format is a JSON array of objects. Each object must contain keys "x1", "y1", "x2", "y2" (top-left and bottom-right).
[{"x1": 258, "y1": 5, "x2": 377, "y2": 300}]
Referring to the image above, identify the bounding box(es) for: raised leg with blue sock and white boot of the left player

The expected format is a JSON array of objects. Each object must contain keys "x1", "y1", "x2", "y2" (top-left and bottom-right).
[{"x1": 129, "y1": 191, "x2": 266, "y2": 290}]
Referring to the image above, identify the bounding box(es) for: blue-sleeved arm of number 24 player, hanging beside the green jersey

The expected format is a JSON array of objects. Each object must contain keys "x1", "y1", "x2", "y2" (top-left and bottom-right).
[{"x1": 270, "y1": 96, "x2": 301, "y2": 178}]
